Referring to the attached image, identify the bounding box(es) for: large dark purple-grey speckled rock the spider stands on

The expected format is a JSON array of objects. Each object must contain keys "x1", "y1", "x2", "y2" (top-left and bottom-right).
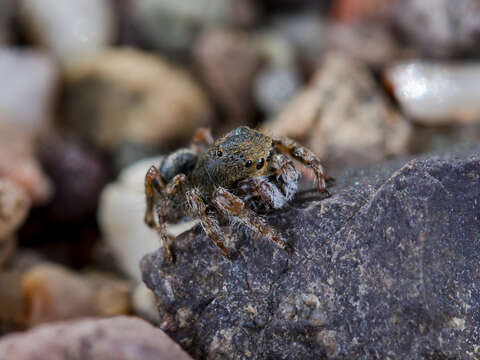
[{"x1": 141, "y1": 146, "x2": 480, "y2": 359}]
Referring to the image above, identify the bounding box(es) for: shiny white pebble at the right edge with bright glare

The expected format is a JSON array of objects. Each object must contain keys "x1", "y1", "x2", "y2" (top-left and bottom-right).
[{"x1": 384, "y1": 61, "x2": 480, "y2": 125}]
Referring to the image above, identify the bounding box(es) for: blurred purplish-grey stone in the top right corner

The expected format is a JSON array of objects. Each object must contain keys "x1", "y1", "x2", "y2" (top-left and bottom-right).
[{"x1": 394, "y1": 0, "x2": 480, "y2": 58}]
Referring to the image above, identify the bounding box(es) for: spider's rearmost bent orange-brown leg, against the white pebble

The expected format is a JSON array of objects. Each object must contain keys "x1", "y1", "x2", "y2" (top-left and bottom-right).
[{"x1": 145, "y1": 166, "x2": 173, "y2": 261}]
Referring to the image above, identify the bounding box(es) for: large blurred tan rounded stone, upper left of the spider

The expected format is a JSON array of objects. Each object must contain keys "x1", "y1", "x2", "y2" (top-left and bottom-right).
[{"x1": 65, "y1": 49, "x2": 212, "y2": 151}]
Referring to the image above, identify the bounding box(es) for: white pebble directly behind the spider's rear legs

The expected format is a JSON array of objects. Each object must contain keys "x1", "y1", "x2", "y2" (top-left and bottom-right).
[{"x1": 98, "y1": 157, "x2": 198, "y2": 282}]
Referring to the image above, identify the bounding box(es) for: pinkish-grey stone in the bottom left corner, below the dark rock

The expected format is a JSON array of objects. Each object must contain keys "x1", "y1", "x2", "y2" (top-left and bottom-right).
[{"x1": 0, "y1": 316, "x2": 191, "y2": 360}]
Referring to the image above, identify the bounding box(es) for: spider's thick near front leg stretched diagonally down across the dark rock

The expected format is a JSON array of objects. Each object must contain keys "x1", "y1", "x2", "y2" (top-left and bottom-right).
[{"x1": 213, "y1": 188, "x2": 292, "y2": 251}]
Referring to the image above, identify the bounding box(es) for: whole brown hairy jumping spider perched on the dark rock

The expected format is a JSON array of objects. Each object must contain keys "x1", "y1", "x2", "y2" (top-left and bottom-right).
[{"x1": 145, "y1": 126, "x2": 328, "y2": 260}]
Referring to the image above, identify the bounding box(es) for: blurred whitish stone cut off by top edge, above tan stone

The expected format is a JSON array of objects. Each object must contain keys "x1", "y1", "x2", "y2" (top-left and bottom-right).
[{"x1": 19, "y1": 0, "x2": 115, "y2": 65}]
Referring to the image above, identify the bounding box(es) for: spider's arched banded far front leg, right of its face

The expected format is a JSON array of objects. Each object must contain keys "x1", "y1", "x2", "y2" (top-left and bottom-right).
[{"x1": 273, "y1": 136, "x2": 328, "y2": 194}]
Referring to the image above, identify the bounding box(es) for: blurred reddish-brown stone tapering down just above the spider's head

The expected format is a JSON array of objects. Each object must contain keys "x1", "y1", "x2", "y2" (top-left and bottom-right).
[{"x1": 194, "y1": 30, "x2": 260, "y2": 127}]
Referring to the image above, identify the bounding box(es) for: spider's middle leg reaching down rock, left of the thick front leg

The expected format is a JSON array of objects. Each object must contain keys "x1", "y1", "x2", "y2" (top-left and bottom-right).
[{"x1": 186, "y1": 188, "x2": 231, "y2": 258}]
